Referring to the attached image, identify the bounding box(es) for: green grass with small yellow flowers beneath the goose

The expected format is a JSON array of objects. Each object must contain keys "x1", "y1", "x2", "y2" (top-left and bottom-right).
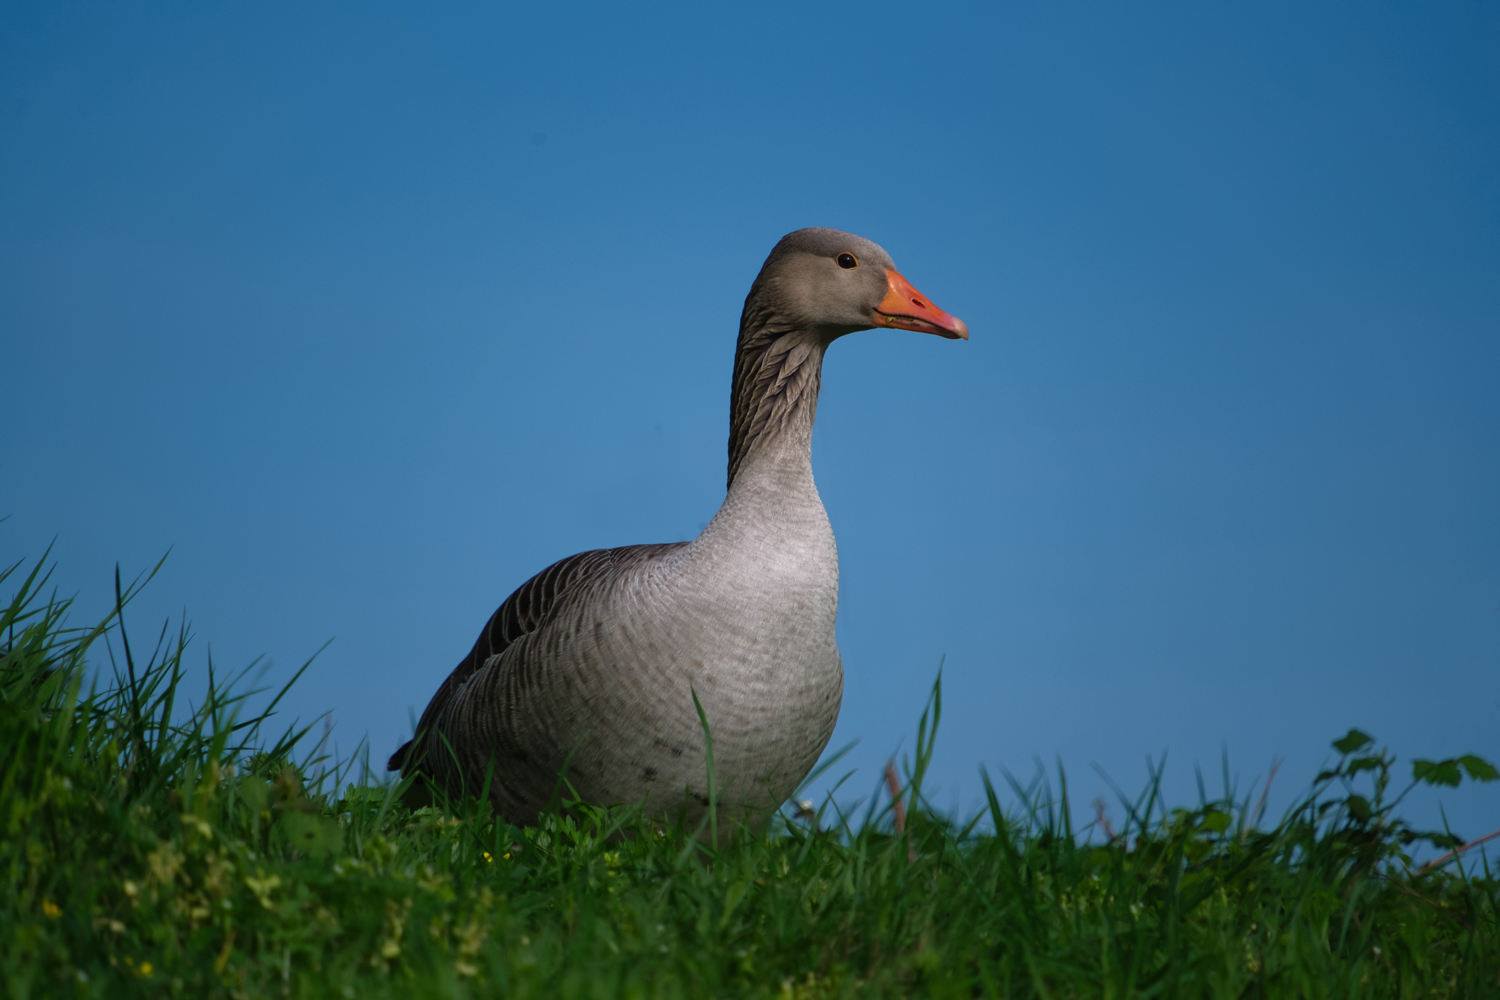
[{"x1": 0, "y1": 562, "x2": 1500, "y2": 1000}]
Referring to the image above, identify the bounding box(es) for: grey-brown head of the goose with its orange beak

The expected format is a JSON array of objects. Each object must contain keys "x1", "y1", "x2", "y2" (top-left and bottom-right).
[{"x1": 746, "y1": 228, "x2": 969, "y2": 342}]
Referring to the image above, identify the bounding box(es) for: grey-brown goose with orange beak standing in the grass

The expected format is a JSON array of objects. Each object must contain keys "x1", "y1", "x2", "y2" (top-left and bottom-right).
[{"x1": 387, "y1": 228, "x2": 969, "y2": 826}]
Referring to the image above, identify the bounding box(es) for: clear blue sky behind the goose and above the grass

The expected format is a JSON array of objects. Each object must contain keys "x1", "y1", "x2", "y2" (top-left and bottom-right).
[{"x1": 0, "y1": 3, "x2": 1500, "y2": 835}]
